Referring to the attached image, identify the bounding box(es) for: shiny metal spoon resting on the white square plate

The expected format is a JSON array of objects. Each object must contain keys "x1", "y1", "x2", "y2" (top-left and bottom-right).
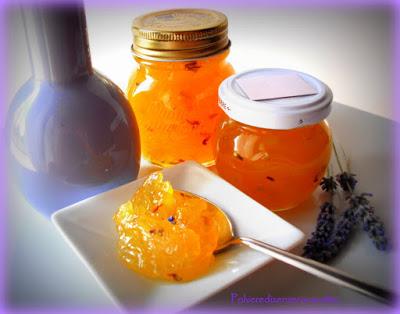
[{"x1": 179, "y1": 191, "x2": 394, "y2": 304}]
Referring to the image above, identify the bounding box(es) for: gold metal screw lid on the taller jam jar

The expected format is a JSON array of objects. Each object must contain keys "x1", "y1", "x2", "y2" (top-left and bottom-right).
[{"x1": 132, "y1": 9, "x2": 230, "y2": 61}]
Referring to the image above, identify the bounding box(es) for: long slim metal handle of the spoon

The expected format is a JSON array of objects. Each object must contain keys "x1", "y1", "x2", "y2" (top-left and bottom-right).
[{"x1": 238, "y1": 237, "x2": 394, "y2": 304}]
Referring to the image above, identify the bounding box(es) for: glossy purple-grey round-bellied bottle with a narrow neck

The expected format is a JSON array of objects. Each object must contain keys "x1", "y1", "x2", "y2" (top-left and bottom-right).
[{"x1": 7, "y1": 5, "x2": 140, "y2": 216}]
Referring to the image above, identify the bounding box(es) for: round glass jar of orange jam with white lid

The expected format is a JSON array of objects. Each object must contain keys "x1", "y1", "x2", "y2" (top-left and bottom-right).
[{"x1": 216, "y1": 69, "x2": 332, "y2": 211}]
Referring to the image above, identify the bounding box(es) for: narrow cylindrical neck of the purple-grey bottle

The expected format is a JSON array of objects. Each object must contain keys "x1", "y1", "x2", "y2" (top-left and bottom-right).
[{"x1": 23, "y1": 5, "x2": 93, "y2": 83}]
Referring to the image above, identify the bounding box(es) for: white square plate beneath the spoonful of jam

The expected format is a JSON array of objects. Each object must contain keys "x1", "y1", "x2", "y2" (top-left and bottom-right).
[{"x1": 52, "y1": 162, "x2": 304, "y2": 310}]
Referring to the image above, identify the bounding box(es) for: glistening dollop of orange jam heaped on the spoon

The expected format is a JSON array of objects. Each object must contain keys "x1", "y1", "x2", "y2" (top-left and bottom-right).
[{"x1": 114, "y1": 172, "x2": 230, "y2": 281}]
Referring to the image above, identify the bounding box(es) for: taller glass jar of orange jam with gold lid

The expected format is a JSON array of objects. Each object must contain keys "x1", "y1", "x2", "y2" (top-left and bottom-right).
[{"x1": 127, "y1": 9, "x2": 233, "y2": 167}]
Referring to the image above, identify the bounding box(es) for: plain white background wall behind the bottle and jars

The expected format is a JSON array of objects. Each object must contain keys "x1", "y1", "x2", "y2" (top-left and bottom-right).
[{"x1": 8, "y1": 0, "x2": 393, "y2": 118}]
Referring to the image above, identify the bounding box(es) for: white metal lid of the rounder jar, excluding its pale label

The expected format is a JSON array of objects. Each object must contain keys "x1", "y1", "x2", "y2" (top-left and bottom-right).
[{"x1": 218, "y1": 69, "x2": 333, "y2": 130}]
